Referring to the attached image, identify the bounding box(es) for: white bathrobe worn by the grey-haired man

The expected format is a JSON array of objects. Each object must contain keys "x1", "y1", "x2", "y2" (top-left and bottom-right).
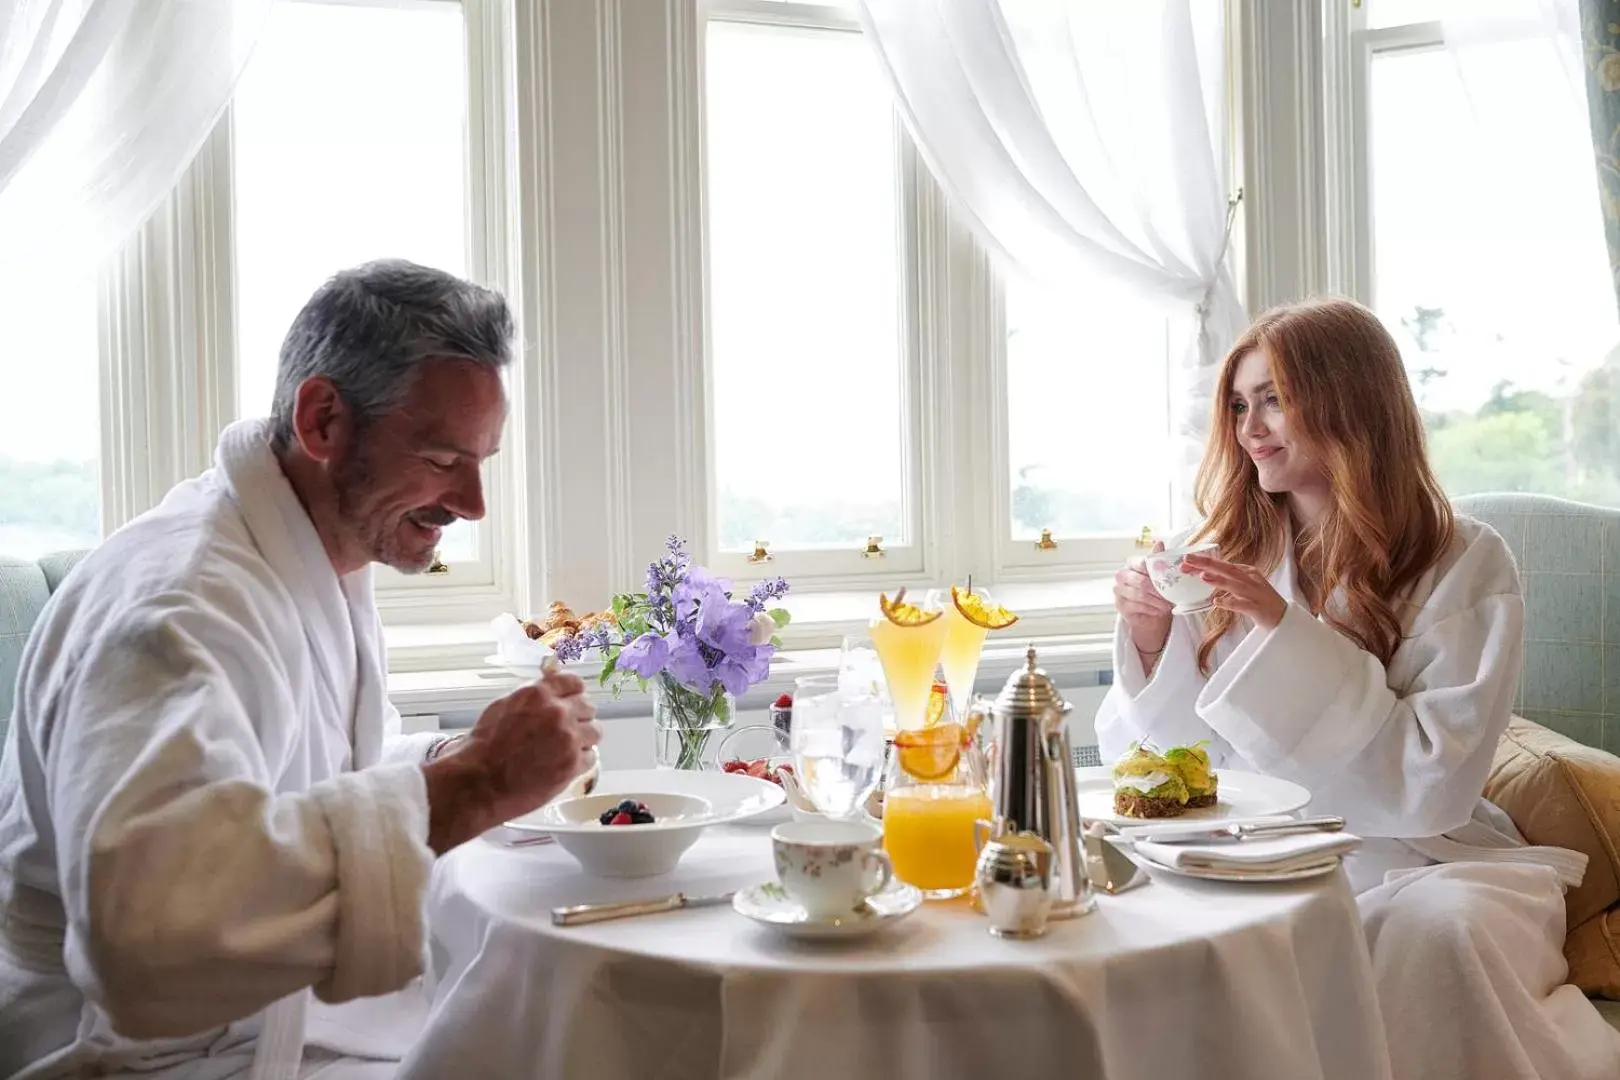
[{"x1": 0, "y1": 421, "x2": 434, "y2": 1080}]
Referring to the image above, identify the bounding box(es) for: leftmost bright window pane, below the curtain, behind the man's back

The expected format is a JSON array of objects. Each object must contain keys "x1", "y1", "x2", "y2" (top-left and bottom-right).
[{"x1": 0, "y1": 279, "x2": 100, "y2": 559}]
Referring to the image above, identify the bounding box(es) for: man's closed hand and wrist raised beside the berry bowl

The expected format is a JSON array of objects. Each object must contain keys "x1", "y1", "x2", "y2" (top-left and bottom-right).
[{"x1": 423, "y1": 672, "x2": 601, "y2": 855}]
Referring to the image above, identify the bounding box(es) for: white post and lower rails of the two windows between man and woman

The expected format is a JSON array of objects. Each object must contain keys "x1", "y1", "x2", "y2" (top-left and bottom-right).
[{"x1": 700, "y1": 0, "x2": 1205, "y2": 610}]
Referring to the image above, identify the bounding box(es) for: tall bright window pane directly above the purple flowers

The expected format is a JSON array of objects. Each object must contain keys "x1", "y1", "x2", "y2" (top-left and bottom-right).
[{"x1": 705, "y1": 8, "x2": 914, "y2": 565}]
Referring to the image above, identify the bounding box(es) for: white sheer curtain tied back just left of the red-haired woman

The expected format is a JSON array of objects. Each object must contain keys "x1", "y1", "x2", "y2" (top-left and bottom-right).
[{"x1": 860, "y1": 0, "x2": 1247, "y2": 476}]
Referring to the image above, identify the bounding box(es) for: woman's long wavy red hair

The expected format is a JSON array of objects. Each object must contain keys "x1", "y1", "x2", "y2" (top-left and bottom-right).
[{"x1": 1196, "y1": 300, "x2": 1455, "y2": 674}]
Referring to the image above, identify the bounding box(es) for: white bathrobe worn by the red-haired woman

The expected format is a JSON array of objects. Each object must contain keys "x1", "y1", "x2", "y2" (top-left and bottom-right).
[{"x1": 1097, "y1": 518, "x2": 1620, "y2": 1080}]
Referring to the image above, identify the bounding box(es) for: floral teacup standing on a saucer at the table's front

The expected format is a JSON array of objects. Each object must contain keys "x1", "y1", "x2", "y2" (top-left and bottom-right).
[{"x1": 771, "y1": 821, "x2": 894, "y2": 920}]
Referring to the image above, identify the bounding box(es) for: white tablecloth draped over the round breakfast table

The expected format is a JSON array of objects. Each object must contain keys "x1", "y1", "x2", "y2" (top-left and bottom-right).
[{"x1": 400, "y1": 826, "x2": 1388, "y2": 1080}]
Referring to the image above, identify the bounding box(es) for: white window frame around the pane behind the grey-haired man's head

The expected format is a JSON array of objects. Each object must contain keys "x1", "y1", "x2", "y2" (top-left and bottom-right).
[{"x1": 99, "y1": 0, "x2": 523, "y2": 623}]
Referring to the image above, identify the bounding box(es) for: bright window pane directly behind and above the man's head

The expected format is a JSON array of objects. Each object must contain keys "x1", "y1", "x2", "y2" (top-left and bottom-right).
[{"x1": 233, "y1": 0, "x2": 480, "y2": 563}]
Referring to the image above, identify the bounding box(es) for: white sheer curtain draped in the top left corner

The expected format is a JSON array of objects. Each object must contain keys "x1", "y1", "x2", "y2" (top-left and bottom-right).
[{"x1": 0, "y1": 0, "x2": 271, "y2": 280}]
